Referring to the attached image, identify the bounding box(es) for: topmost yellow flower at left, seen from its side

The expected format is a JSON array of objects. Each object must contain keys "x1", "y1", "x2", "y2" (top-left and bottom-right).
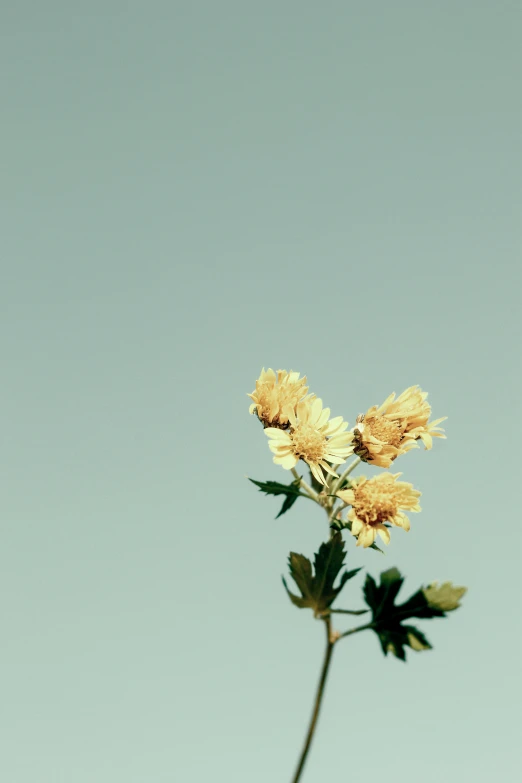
[{"x1": 248, "y1": 367, "x2": 308, "y2": 429}]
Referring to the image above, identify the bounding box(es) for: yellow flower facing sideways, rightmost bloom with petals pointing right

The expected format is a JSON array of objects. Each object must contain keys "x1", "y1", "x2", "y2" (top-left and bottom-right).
[{"x1": 354, "y1": 386, "x2": 446, "y2": 468}]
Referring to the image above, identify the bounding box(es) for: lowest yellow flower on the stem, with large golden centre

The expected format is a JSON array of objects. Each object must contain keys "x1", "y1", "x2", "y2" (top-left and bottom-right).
[{"x1": 337, "y1": 473, "x2": 421, "y2": 547}]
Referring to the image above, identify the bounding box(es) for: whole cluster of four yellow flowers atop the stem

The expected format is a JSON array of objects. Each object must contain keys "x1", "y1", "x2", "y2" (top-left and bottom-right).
[{"x1": 248, "y1": 369, "x2": 446, "y2": 547}]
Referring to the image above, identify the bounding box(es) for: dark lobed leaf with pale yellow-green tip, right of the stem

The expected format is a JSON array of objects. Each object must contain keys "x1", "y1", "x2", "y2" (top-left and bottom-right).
[{"x1": 363, "y1": 568, "x2": 466, "y2": 661}]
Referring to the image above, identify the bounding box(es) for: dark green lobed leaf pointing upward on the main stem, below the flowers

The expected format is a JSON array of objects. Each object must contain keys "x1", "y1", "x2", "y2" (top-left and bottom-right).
[{"x1": 283, "y1": 533, "x2": 361, "y2": 617}]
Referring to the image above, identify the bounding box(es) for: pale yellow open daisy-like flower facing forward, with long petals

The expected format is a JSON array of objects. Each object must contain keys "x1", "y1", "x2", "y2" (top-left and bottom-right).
[{"x1": 265, "y1": 395, "x2": 353, "y2": 484}]
